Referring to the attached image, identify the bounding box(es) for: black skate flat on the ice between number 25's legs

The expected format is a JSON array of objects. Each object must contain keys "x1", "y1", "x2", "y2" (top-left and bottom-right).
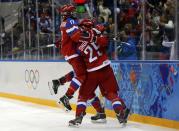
[{"x1": 91, "y1": 112, "x2": 107, "y2": 123}]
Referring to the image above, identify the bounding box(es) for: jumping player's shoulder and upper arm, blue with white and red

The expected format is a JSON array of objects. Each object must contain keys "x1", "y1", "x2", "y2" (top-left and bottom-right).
[{"x1": 66, "y1": 19, "x2": 81, "y2": 42}]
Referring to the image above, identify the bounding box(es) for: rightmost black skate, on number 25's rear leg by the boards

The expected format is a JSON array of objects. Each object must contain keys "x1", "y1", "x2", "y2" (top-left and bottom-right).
[{"x1": 116, "y1": 108, "x2": 130, "y2": 124}]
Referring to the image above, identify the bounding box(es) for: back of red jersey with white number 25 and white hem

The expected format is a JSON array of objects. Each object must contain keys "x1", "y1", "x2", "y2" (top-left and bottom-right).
[{"x1": 77, "y1": 30, "x2": 110, "y2": 72}]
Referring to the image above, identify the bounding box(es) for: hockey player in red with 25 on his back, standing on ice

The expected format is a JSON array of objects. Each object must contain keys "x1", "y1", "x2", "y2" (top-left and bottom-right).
[{"x1": 64, "y1": 20, "x2": 129, "y2": 126}]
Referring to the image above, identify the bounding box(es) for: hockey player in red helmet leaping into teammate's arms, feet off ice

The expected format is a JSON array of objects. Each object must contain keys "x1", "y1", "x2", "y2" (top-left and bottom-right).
[{"x1": 53, "y1": 5, "x2": 86, "y2": 110}]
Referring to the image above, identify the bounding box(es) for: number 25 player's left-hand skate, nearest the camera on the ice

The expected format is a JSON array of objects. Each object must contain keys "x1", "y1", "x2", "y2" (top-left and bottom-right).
[{"x1": 69, "y1": 113, "x2": 86, "y2": 127}]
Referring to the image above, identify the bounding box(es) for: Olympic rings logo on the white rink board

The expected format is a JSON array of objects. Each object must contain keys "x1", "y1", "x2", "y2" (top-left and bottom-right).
[{"x1": 25, "y1": 69, "x2": 40, "y2": 90}]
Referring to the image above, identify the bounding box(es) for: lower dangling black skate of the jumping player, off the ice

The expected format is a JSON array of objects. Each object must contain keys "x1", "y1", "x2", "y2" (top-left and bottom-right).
[{"x1": 58, "y1": 95, "x2": 72, "y2": 112}]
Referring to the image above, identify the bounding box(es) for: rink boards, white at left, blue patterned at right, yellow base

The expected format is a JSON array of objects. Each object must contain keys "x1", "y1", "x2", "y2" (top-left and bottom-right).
[{"x1": 0, "y1": 61, "x2": 179, "y2": 129}]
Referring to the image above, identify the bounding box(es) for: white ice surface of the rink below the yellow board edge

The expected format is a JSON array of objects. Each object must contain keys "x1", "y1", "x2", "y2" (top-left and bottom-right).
[{"x1": 0, "y1": 98, "x2": 176, "y2": 131}]
